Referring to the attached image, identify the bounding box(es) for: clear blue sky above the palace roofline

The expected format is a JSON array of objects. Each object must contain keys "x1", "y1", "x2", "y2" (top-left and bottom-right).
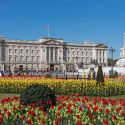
[{"x1": 0, "y1": 0, "x2": 125, "y2": 58}]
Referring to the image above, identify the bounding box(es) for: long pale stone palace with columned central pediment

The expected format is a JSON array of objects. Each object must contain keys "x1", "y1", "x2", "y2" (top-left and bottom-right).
[{"x1": 0, "y1": 36, "x2": 108, "y2": 71}]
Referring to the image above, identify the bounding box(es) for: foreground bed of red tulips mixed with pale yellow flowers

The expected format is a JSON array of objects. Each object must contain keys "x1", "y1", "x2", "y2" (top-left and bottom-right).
[{"x1": 0, "y1": 94, "x2": 125, "y2": 125}]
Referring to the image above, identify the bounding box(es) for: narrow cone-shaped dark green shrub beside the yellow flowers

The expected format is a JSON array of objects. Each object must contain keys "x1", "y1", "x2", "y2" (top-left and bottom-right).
[{"x1": 96, "y1": 65, "x2": 104, "y2": 85}]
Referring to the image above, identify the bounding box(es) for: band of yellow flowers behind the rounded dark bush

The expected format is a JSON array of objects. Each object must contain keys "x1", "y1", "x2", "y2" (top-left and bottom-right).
[{"x1": 0, "y1": 78, "x2": 125, "y2": 96}]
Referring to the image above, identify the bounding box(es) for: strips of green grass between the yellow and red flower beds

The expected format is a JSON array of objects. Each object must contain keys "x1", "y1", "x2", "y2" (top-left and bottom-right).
[{"x1": 0, "y1": 93, "x2": 125, "y2": 100}]
